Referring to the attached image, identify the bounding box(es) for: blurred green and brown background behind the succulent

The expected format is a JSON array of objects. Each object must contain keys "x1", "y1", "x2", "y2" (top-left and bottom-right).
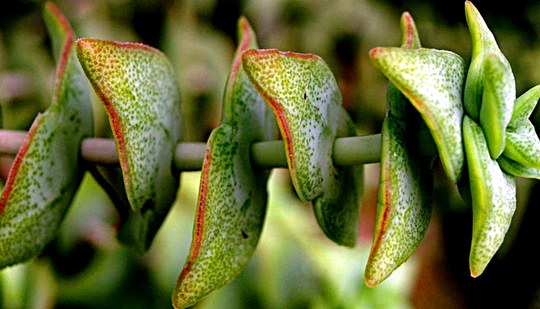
[{"x1": 0, "y1": 0, "x2": 540, "y2": 309}]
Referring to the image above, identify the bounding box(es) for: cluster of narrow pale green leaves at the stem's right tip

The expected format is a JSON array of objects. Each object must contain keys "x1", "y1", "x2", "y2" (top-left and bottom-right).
[{"x1": 459, "y1": 1, "x2": 540, "y2": 277}]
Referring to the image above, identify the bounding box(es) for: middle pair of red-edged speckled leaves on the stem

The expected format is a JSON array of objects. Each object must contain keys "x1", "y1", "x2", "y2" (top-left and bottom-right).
[{"x1": 173, "y1": 18, "x2": 363, "y2": 308}]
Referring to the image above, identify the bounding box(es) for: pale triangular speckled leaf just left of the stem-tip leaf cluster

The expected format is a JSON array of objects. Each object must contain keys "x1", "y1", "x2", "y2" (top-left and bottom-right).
[{"x1": 370, "y1": 47, "x2": 465, "y2": 183}]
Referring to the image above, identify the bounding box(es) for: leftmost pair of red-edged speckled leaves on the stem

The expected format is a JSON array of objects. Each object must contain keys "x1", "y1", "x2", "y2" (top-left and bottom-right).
[{"x1": 0, "y1": 3, "x2": 181, "y2": 267}]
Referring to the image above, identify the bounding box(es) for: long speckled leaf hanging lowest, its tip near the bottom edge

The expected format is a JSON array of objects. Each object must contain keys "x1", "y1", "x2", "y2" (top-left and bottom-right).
[{"x1": 173, "y1": 18, "x2": 279, "y2": 308}]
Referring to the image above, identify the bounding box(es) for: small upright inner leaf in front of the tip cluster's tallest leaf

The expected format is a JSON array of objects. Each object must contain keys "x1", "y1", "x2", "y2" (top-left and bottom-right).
[{"x1": 480, "y1": 54, "x2": 516, "y2": 159}]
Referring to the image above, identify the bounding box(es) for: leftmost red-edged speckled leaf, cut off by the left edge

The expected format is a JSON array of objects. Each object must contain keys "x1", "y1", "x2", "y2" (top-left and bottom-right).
[{"x1": 0, "y1": 3, "x2": 93, "y2": 267}]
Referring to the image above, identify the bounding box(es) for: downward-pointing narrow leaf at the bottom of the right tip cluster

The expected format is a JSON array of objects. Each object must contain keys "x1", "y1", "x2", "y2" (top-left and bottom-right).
[{"x1": 463, "y1": 116, "x2": 516, "y2": 277}]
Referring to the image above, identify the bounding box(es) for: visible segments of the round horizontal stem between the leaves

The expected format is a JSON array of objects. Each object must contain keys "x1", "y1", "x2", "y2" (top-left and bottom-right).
[{"x1": 0, "y1": 130, "x2": 435, "y2": 171}]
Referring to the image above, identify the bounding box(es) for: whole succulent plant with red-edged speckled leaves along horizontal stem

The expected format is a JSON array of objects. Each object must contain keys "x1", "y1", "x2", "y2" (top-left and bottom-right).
[{"x1": 0, "y1": 1, "x2": 540, "y2": 308}]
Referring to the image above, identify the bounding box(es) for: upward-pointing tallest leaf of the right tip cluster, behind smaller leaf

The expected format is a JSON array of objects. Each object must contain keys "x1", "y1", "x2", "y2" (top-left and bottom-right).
[{"x1": 464, "y1": 1, "x2": 515, "y2": 126}]
